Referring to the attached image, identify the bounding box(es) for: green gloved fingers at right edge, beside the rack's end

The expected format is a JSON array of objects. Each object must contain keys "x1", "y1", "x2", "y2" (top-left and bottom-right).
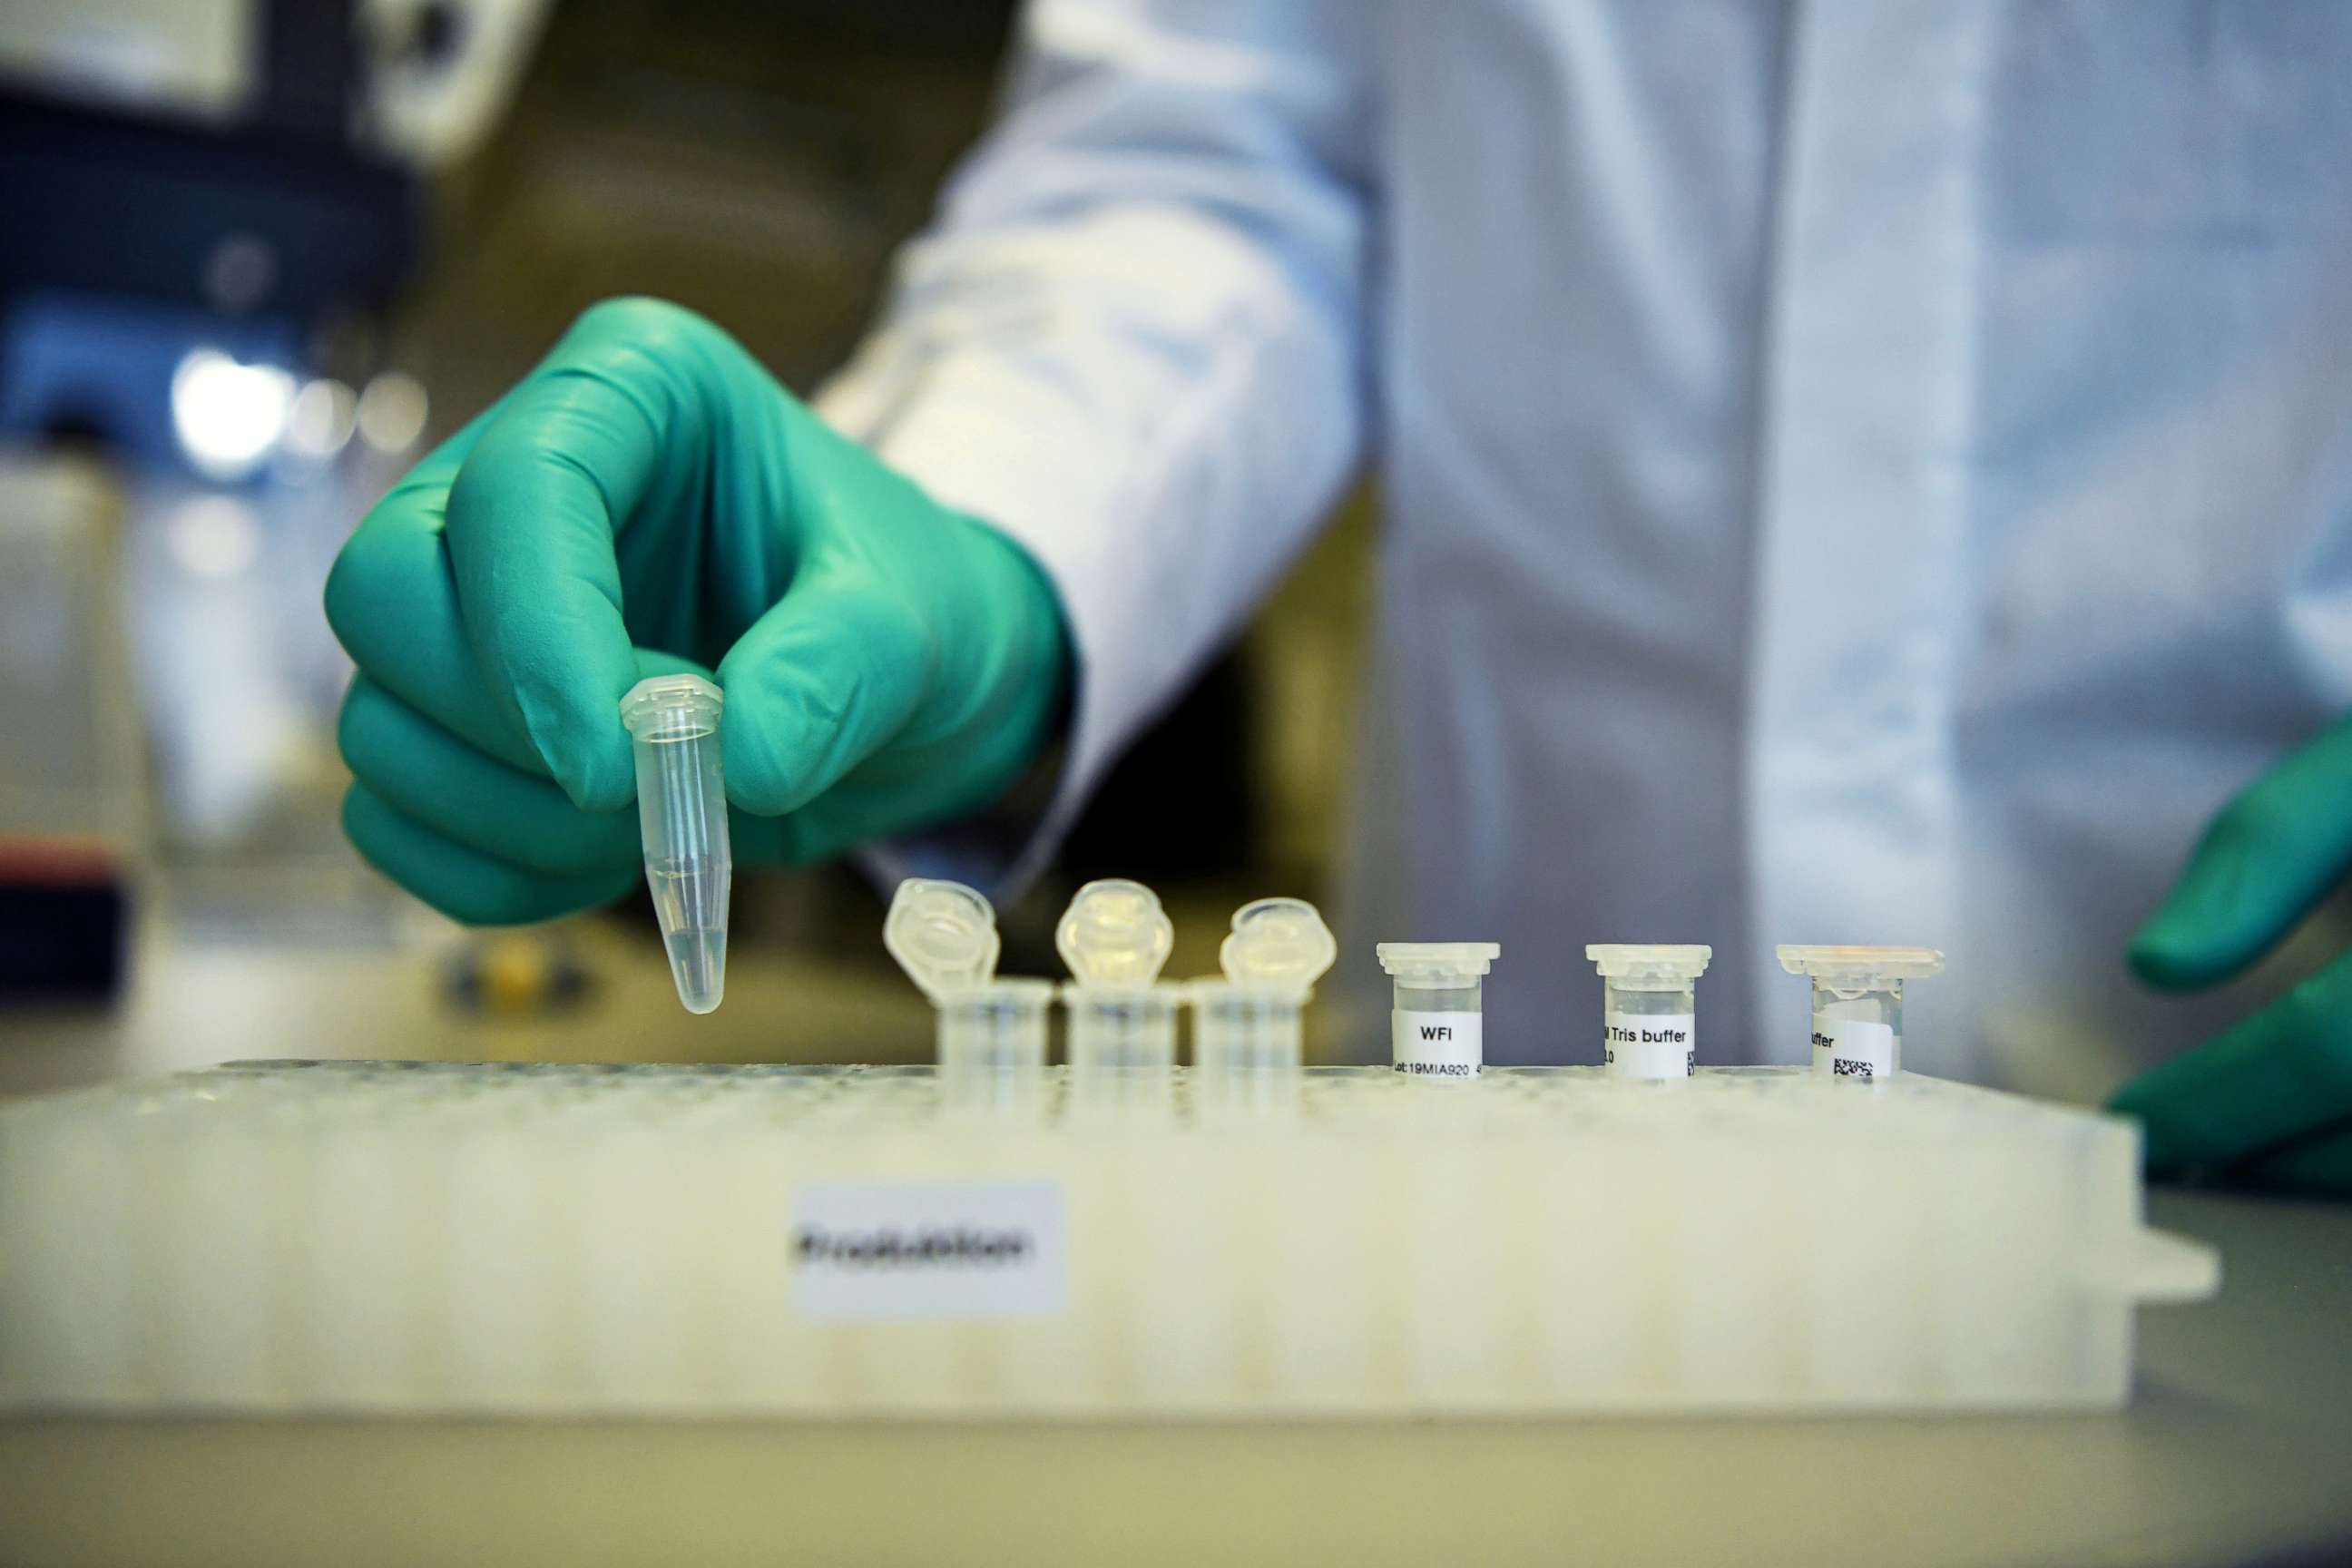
[{"x1": 2110, "y1": 720, "x2": 2352, "y2": 1194}]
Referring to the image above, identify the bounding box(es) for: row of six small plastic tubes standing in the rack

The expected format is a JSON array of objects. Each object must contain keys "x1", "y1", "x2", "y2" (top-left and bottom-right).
[{"x1": 882, "y1": 877, "x2": 1943, "y2": 1079}]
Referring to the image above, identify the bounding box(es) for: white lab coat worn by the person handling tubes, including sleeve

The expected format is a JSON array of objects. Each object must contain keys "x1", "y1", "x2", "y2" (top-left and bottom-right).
[{"x1": 821, "y1": 0, "x2": 2352, "y2": 1093}]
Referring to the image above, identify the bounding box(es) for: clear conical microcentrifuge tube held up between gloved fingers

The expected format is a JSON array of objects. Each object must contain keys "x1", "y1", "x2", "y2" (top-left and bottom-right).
[{"x1": 621, "y1": 675, "x2": 734, "y2": 1014}]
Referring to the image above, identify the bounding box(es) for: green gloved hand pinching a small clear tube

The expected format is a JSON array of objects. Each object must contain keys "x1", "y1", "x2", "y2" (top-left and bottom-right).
[{"x1": 327, "y1": 299, "x2": 1070, "y2": 924}]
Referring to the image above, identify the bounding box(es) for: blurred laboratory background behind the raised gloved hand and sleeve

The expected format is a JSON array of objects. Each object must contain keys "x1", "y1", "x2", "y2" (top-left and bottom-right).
[{"x1": 0, "y1": 0, "x2": 1374, "y2": 1093}]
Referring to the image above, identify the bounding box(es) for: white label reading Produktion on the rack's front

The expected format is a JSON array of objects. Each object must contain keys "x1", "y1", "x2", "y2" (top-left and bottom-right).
[{"x1": 790, "y1": 1182, "x2": 1070, "y2": 1324}]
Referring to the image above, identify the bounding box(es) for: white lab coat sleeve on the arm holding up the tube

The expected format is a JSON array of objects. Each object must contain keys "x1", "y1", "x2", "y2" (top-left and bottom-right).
[{"x1": 816, "y1": 0, "x2": 1374, "y2": 887}]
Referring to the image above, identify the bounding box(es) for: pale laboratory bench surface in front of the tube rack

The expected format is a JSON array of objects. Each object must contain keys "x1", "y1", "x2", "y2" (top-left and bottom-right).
[{"x1": 0, "y1": 1191, "x2": 2352, "y2": 1568}]
